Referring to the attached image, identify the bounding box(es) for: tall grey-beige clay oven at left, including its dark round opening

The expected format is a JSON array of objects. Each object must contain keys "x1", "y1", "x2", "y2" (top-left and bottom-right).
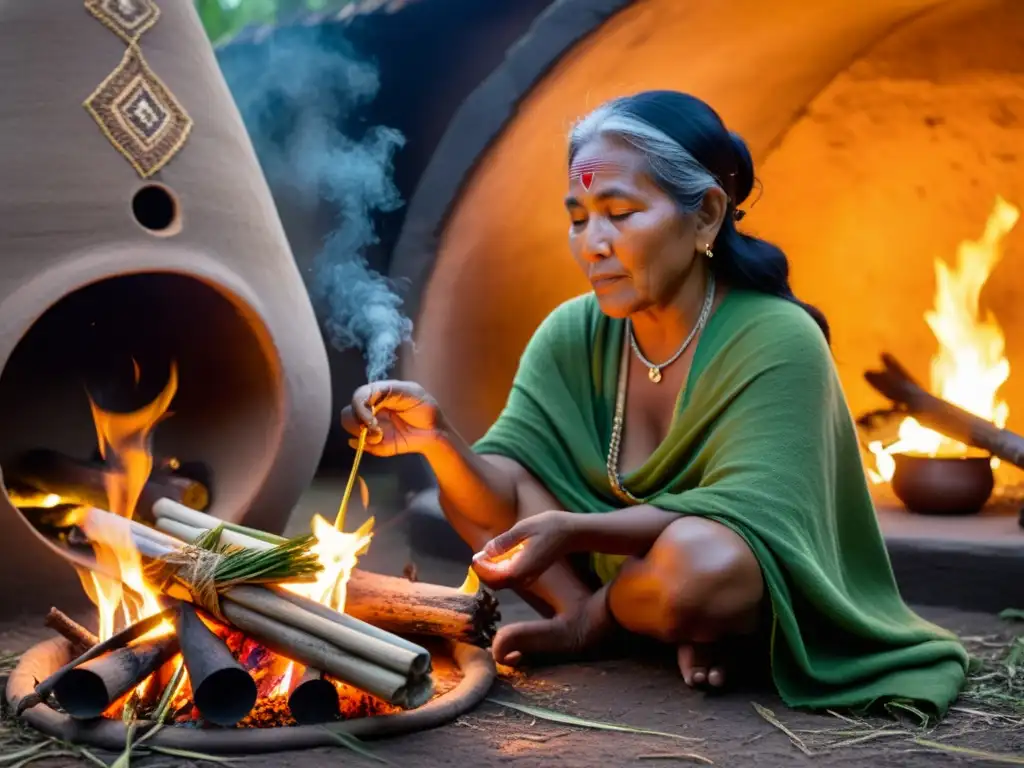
[{"x1": 0, "y1": 0, "x2": 331, "y2": 611}]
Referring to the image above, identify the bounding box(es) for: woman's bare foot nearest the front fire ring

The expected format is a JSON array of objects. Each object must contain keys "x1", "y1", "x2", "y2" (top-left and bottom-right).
[{"x1": 490, "y1": 591, "x2": 614, "y2": 667}]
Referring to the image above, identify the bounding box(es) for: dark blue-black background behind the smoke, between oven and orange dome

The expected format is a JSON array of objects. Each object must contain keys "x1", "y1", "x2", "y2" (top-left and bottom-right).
[{"x1": 218, "y1": 0, "x2": 553, "y2": 489}]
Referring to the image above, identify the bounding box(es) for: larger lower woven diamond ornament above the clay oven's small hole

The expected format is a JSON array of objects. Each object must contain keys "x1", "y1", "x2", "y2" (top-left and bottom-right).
[{"x1": 85, "y1": 47, "x2": 193, "y2": 178}]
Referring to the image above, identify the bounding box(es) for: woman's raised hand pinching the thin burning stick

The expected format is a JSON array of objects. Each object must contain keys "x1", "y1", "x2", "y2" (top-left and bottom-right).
[{"x1": 341, "y1": 381, "x2": 442, "y2": 456}]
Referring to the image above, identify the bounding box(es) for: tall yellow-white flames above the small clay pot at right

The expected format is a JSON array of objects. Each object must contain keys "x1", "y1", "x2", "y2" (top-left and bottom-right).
[{"x1": 868, "y1": 197, "x2": 1020, "y2": 483}]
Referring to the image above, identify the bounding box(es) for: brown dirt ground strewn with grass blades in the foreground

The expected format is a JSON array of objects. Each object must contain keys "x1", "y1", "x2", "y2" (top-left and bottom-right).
[{"x1": 0, "y1": 483, "x2": 1024, "y2": 768}]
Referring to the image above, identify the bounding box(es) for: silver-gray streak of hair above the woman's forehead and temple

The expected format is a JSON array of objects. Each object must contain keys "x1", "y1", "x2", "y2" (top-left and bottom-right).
[{"x1": 569, "y1": 101, "x2": 728, "y2": 212}]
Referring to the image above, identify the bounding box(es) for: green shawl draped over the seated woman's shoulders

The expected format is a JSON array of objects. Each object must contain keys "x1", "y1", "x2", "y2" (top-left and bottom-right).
[{"x1": 474, "y1": 291, "x2": 968, "y2": 717}]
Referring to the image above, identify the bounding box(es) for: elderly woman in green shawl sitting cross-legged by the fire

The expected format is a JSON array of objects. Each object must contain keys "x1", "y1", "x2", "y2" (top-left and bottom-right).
[{"x1": 343, "y1": 91, "x2": 968, "y2": 717}]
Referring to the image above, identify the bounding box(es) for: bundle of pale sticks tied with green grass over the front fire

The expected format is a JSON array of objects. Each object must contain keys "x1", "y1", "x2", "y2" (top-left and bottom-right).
[{"x1": 64, "y1": 500, "x2": 433, "y2": 709}]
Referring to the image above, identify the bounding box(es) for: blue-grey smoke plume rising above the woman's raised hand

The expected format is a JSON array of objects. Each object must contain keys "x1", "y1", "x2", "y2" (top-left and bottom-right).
[{"x1": 220, "y1": 28, "x2": 413, "y2": 381}]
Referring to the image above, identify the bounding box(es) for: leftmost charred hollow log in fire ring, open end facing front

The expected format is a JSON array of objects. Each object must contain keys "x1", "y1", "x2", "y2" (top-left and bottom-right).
[{"x1": 53, "y1": 633, "x2": 178, "y2": 720}]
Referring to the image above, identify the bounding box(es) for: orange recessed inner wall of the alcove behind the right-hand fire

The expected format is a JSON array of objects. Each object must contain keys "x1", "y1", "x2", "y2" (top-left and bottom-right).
[{"x1": 748, "y1": 0, "x2": 1024, "y2": 438}]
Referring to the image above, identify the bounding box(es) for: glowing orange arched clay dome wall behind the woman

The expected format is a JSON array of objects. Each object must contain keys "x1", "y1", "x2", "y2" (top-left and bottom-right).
[{"x1": 391, "y1": 0, "x2": 1024, "y2": 437}]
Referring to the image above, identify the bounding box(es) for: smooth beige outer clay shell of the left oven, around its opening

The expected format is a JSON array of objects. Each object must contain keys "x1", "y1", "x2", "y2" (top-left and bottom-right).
[{"x1": 0, "y1": 0, "x2": 331, "y2": 529}]
